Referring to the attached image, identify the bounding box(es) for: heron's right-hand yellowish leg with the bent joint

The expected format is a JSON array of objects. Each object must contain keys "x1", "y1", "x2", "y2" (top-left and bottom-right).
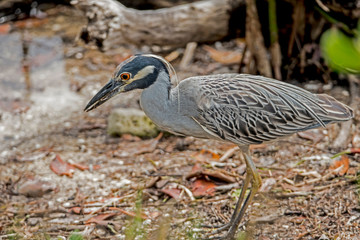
[{"x1": 223, "y1": 148, "x2": 261, "y2": 239}]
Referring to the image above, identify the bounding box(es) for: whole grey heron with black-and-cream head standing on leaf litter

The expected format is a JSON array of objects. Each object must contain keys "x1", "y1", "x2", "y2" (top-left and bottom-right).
[{"x1": 85, "y1": 54, "x2": 353, "y2": 239}]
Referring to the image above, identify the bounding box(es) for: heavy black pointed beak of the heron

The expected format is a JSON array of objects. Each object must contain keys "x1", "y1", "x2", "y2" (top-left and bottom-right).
[{"x1": 84, "y1": 79, "x2": 124, "y2": 112}]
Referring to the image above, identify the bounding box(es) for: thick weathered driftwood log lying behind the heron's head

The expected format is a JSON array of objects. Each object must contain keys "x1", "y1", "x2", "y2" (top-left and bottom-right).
[{"x1": 73, "y1": 0, "x2": 245, "y2": 49}]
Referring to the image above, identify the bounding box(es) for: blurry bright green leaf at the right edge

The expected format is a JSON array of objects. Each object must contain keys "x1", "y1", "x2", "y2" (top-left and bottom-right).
[{"x1": 320, "y1": 28, "x2": 360, "y2": 74}]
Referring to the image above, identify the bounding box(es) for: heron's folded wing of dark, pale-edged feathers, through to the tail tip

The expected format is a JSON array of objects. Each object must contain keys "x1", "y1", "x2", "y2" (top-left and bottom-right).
[{"x1": 187, "y1": 74, "x2": 352, "y2": 144}]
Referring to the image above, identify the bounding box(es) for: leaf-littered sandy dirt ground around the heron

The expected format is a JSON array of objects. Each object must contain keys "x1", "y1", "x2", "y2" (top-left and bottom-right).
[{"x1": 0, "y1": 4, "x2": 360, "y2": 240}]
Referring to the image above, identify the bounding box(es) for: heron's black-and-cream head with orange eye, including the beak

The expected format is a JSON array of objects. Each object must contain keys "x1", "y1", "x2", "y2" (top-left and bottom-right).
[{"x1": 84, "y1": 54, "x2": 173, "y2": 112}]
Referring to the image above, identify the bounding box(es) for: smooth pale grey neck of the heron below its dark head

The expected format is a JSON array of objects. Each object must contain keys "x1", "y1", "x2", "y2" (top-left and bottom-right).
[{"x1": 140, "y1": 71, "x2": 171, "y2": 123}]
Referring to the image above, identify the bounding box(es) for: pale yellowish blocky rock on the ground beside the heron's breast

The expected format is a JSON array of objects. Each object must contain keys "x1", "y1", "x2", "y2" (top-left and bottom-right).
[{"x1": 107, "y1": 108, "x2": 159, "y2": 137}]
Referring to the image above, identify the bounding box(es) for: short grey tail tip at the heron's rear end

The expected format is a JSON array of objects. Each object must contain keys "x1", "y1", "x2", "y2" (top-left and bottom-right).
[{"x1": 317, "y1": 94, "x2": 354, "y2": 122}]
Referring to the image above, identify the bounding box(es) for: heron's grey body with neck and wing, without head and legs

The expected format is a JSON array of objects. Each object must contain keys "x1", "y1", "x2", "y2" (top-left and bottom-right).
[{"x1": 141, "y1": 70, "x2": 353, "y2": 145}]
